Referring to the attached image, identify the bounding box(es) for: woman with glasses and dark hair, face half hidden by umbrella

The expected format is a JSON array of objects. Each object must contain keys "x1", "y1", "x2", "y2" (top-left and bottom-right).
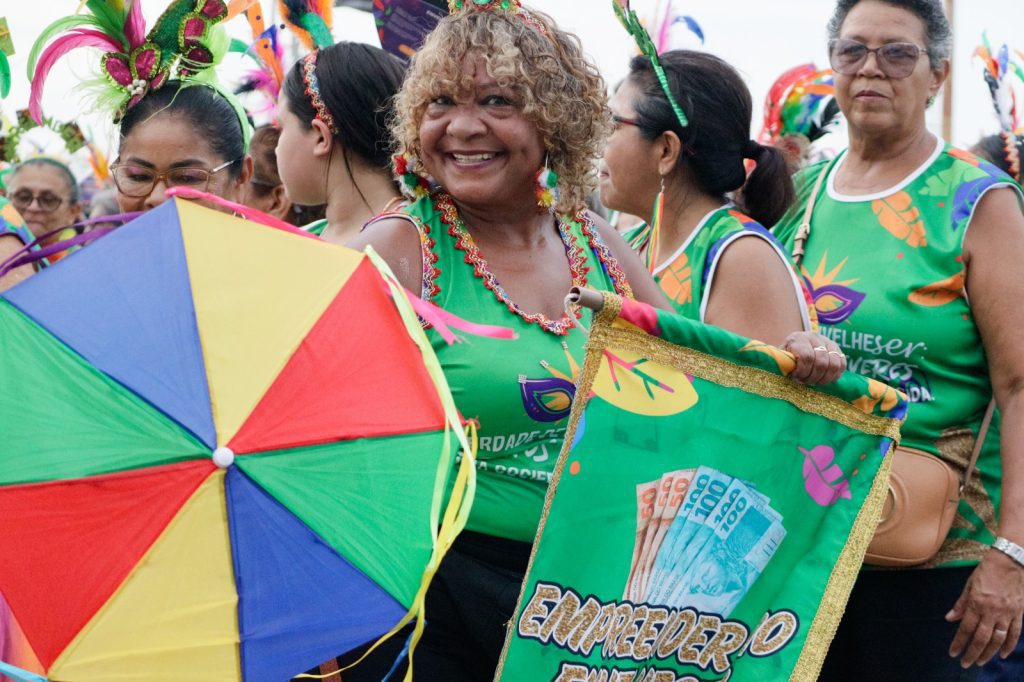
[{"x1": 111, "y1": 81, "x2": 253, "y2": 212}]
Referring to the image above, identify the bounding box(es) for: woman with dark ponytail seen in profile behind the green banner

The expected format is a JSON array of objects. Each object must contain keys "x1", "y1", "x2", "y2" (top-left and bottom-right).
[{"x1": 600, "y1": 50, "x2": 815, "y2": 346}]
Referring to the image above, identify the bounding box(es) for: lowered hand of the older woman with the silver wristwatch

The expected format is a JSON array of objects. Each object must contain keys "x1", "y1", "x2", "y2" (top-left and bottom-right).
[{"x1": 946, "y1": 549, "x2": 1024, "y2": 668}]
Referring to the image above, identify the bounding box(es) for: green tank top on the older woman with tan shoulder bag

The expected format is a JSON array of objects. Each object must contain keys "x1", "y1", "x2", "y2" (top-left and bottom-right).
[{"x1": 775, "y1": 140, "x2": 1020, "y2": 565}]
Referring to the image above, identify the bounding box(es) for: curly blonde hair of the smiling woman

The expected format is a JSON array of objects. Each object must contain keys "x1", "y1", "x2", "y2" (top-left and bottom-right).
[{"x1": 392, "y1": 10, "x2": 611, "y2": 215}]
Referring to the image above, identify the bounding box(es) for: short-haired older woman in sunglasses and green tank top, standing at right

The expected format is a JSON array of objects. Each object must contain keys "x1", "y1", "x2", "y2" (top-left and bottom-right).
[{"x1": 776, "y1": 0, "x2": 1024, "y2": 680}]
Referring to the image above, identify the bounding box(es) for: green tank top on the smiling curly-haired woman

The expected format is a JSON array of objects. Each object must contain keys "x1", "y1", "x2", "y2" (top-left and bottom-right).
[{"x1": 389, "y1": 191, "x2": 632, "y2": 543}]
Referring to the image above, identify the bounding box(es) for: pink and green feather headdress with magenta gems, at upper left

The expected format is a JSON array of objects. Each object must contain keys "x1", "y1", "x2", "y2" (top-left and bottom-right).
[{"x1": 29, "y1": 0, "x2": 229, "y2": 122}]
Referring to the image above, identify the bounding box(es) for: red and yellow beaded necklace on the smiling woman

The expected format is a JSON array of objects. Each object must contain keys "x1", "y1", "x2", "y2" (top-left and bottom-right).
[{"x1": 435, "y1": 194, "x2": 588, "y2": 336}]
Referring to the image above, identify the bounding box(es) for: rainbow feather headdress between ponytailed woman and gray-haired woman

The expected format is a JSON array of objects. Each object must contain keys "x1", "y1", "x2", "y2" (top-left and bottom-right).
[{"x1": 760, "y1": 63, "x2": 840, "y2": 144}]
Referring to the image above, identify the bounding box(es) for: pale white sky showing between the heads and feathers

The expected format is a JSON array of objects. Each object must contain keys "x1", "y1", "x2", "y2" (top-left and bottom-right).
[{"x1": 0, "y1": 0, "x2": 1024, "y2": 179}]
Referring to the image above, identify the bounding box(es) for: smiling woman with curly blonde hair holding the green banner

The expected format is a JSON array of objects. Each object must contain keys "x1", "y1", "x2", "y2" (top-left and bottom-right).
[{"x1": 349, "y1": 2, "x2": 668, "y2": 681}]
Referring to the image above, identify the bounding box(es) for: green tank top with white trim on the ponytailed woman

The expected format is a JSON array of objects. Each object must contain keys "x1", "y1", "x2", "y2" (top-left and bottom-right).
[{"x1": 624, "y1": 206, "x2": 814, "y2": 331}]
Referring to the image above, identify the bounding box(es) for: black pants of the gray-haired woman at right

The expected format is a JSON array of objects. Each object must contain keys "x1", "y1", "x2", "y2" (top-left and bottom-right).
[{"x1": 819, "y1": 568, "x2": 978, "y2": 682}]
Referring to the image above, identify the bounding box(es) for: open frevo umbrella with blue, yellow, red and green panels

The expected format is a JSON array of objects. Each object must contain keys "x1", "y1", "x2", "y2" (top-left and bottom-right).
[{"x1": 0, "y1": 200, "x2": 472, "y2": 682}]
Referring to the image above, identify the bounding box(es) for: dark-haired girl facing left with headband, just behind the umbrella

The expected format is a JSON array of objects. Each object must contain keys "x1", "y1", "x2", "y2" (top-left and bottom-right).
[{"x1": 278, "y1": 42, "x2": 404, "y2": 244}]
